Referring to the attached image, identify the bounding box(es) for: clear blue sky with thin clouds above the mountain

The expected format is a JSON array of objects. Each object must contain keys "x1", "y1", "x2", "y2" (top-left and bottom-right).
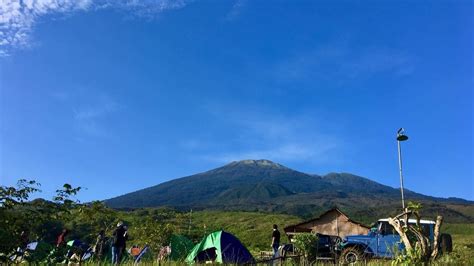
[{"x1": 0, "y1": 0, "x2": 474, "y2": 201}]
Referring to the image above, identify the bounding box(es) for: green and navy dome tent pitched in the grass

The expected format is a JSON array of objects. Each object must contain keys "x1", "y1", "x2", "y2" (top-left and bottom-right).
[{"x1": 186, "y1": 231, "x2": 254, "y2": 264}]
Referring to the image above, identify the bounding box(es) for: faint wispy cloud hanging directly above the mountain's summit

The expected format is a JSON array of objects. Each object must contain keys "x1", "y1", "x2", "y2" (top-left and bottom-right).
[{"x1": 181, "y1": 105, "x2": 344, "y2": 164}]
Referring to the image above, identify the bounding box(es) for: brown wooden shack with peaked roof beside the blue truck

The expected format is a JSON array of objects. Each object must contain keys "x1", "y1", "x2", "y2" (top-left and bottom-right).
[{"x1": 284, "y1": 208, "x2": 370, "y2": 240}]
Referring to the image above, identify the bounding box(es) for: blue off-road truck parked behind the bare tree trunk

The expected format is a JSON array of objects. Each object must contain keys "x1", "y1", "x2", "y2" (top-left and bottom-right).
[{"x1": 338, "y1": 219, "x2": 452, "y2": 264}]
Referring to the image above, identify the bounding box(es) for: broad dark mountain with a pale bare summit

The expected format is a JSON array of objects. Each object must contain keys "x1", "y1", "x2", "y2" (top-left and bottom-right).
[{"x1": 105, "y1": 160, "x2": 474, "y2": 222}]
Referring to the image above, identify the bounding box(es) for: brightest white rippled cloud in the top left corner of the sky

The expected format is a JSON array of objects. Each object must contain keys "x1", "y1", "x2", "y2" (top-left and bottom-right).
[{"x1": 0, "y1": 0, "x2": 189, "y2": 56}]
